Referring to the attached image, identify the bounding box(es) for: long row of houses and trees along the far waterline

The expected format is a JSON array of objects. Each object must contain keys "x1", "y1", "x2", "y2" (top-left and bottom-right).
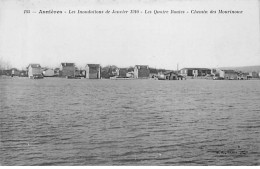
[{"x1": 2, "y1": 63, "x2": 260, "y2": 80}]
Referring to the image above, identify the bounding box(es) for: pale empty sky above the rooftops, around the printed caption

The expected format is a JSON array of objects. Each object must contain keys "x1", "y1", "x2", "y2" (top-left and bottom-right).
[{"x1": 0, "y1": 0, "x2": 260, "y2": 69}]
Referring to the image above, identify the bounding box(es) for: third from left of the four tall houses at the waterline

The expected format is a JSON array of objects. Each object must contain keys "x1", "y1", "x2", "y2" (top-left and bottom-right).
[{"x1": 85, "y1": 64, "x2": 101, "y2": 79}]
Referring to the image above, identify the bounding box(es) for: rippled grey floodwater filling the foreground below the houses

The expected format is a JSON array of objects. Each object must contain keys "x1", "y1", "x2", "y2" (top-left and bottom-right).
[{"x1": 0, "y1": 78, "x2": 260, "y2": 166}]
